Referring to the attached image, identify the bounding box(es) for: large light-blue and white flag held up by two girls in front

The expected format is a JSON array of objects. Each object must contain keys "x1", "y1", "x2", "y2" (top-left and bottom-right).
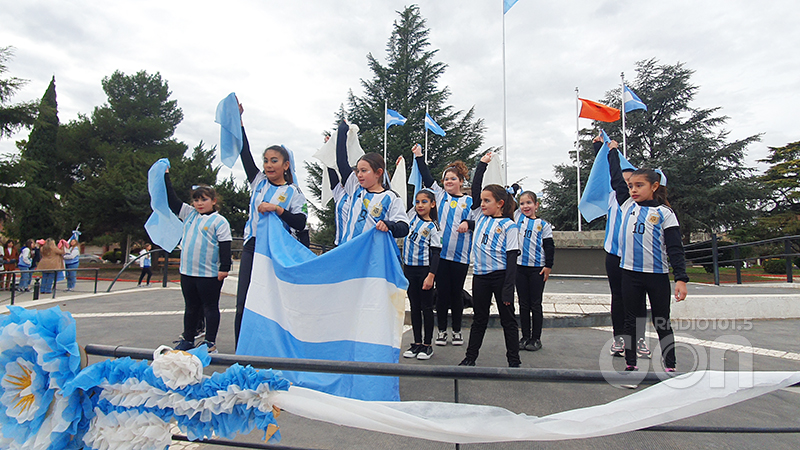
[{"x1": 236, "y1": 213, "x2": 408, "y2": 401}]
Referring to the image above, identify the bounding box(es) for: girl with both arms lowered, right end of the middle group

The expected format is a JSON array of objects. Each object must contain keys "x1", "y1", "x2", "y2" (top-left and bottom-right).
[{"x1": 514, "y1": 191, "x2": 555, "y2": 352}]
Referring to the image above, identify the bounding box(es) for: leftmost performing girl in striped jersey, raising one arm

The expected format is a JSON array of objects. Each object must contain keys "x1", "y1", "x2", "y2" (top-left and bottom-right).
[{"x1": 164, "y1": 174, "x2": 233, "y2": 353}]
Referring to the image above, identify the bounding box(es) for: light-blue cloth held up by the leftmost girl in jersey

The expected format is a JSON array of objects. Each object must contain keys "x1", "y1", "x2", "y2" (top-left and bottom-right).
[{"x1": 144, "y1": 158, "x2": 183, "y2": 252}]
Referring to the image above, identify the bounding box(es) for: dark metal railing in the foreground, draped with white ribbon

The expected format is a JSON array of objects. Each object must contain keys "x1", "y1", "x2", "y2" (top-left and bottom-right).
[{"x1": 85, "y1": 344, "x2": 800, "y2": 449}]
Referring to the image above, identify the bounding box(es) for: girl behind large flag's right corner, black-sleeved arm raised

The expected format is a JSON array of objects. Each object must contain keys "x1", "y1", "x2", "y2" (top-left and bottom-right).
[{"x1": 333, "y1": 121, "x2": 408, "y2": 244}]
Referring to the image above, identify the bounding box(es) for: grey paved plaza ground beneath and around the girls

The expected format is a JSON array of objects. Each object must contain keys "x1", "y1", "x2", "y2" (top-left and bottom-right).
[{"x1": 0, "y1": 279, "x2": 800, "y2": 450}]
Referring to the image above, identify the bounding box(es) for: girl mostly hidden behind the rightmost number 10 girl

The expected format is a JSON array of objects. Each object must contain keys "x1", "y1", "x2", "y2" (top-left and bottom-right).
[{"x1": 592, "y1": 136, "x2": 650, "y2": 358}]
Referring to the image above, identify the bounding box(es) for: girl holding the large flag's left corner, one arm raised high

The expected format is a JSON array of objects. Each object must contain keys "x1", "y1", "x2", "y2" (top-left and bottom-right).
[{"x1": 236, "y1": 103, "x2": 307, "y2": 345}]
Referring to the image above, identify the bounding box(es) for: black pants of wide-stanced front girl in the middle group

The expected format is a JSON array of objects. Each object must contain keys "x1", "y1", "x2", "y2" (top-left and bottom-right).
[{"x1": 466, "y1": 270, "x2": 520, "y2": 365}]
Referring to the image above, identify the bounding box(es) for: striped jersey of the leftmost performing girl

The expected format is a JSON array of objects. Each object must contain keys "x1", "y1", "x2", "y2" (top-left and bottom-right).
[{"x1": 178, "y1": 203, "x2": 233, "y2": 278}]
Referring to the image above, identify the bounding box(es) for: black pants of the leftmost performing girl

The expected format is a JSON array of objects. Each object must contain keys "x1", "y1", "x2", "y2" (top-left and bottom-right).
[{"x1": 181, "y1": 274, "x2": 222, "y2": 342}]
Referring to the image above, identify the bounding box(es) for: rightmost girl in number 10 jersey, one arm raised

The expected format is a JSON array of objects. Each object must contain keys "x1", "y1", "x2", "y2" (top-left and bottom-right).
[{"x1": 608, "y1": 148, "x2": 689, "y2": 372}]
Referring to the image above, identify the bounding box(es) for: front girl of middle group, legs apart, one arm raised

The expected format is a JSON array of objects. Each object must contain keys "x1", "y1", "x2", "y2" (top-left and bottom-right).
[{"x1": 459, "y1": 154, "x2": 520, "y2": 367}]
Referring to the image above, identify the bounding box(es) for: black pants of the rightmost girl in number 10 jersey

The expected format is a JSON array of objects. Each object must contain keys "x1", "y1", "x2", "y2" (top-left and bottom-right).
[{"x1": 621, "y1": 269, "x2": 675, "y2": 368}]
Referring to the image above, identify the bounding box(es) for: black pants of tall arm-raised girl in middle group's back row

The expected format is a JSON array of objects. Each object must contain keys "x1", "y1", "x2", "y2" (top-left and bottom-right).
[{"x1": 436, "y1": 259, "x2": 469, "y2": 332}]
